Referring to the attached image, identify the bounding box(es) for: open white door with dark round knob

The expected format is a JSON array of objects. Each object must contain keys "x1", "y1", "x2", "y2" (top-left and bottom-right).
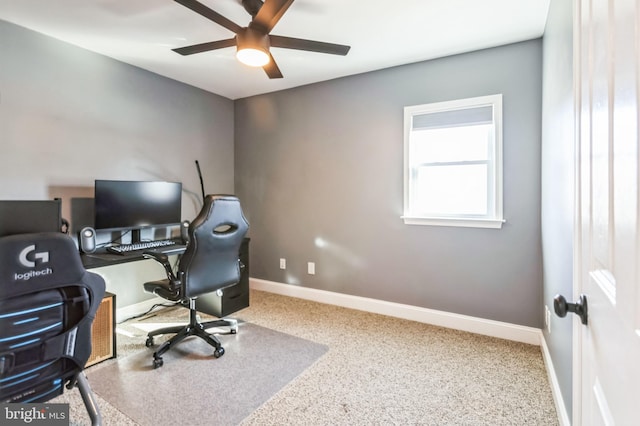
[{"x1": 572, "y1": 0, "x2": 640, "y2": 425}]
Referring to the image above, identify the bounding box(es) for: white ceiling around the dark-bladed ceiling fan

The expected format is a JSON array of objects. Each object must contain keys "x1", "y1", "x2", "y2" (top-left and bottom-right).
[{"x1": 0, "y1": 0, "x2": 550, "y2": 99}]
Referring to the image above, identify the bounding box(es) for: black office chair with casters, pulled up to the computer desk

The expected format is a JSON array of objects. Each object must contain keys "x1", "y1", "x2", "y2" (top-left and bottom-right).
[{"x1": 144, "y1": 195, "x2": 249, "y2": 368}]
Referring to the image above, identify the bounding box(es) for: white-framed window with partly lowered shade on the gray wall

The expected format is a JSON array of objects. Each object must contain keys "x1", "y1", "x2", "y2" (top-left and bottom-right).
[{"x1": 403, "y1": 95, "x2": 504, "y2": 228}]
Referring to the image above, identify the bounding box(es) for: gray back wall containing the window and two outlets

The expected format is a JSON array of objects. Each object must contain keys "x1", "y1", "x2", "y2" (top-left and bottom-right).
[{"x1": 235, "y1": 40, "x2": 542, "y2": 327}]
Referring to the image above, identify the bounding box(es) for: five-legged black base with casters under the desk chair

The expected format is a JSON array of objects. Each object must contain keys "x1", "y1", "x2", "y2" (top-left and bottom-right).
[{"x1": 145, "y1": 299, "x2": 238, "y2": 368}]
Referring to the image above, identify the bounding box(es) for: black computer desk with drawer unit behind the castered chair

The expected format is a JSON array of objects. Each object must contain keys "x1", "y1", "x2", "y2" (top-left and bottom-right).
[{"x1": 80, "y1": 238, "x2": 250, "y2": 318}]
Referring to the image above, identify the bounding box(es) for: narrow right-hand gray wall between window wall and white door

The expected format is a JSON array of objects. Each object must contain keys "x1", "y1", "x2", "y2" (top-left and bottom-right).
[{"x1": 542, "y1": 0, "x2": 575, "y2": 416}]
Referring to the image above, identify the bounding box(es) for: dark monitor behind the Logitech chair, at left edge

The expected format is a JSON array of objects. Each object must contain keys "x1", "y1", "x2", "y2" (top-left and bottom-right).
[{"x1": 0, "y1": 199, "x2": 62, "y2": 237}]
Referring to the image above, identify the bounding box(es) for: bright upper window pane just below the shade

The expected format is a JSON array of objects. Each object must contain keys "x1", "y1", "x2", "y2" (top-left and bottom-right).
[{"x1": 410, "y1": 125, "x2": 492, "y2": 165}]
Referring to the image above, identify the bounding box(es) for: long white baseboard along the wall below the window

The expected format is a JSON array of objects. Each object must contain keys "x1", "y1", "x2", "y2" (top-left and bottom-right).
[{"x1": 249, "y1": 278, "x2": 542, "y2": 345}]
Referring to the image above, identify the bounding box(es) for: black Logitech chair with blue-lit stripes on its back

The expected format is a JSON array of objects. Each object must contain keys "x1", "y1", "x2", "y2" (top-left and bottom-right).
[{"x1": 0, "y1": 233, "x2": 105, "y2": 425}]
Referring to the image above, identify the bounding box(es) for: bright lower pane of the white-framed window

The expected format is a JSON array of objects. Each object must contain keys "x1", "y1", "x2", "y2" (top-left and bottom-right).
[{"x1": 411, "y1": 164, "x2": 488, "y2": 216}]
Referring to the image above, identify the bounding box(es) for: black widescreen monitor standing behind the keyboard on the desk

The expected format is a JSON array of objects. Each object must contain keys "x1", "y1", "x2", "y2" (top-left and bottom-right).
[{"x1": 94, "y1": 180, "x2": 182, "y2": 233}]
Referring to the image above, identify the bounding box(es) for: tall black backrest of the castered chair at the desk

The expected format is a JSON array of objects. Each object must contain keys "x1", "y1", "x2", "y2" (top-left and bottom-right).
[{"x1": 177, "y1": 195, "x2": 249, "y2": 297}]
